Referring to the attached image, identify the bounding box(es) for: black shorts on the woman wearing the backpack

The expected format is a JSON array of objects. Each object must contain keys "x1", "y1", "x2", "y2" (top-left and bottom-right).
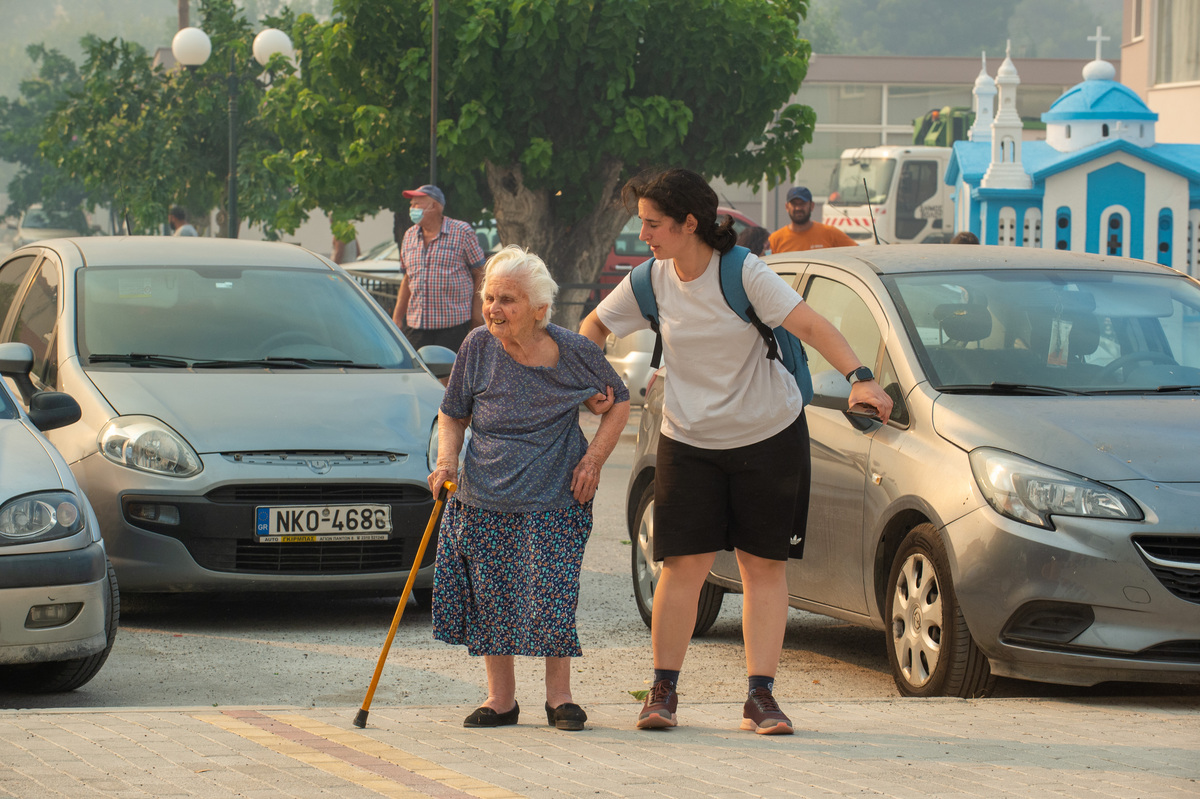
[{"x1": 654, "y1": 413, "x2": 811, "y2": 560}]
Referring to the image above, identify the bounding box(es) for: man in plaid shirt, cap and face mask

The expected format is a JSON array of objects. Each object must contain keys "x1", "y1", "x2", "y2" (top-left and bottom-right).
[{"x1": 391, "y1": 185, "x2": 484, "y2": 352}]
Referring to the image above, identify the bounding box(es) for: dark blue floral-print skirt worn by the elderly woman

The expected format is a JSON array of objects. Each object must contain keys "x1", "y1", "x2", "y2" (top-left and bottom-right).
[{"x1": 433, "y1": 497, "x2": 592, "y2": 657}]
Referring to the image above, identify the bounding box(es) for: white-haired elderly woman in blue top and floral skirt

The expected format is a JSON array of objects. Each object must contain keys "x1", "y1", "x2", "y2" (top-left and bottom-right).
[{"x1": 430, "y1": 247, "x2": 629, "y2": 729}]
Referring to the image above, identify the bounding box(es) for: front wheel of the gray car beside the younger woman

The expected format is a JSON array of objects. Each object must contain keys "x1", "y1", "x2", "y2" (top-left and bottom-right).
[{"x1": 887, "y1": 524, "x2": 996, "y2": 697}]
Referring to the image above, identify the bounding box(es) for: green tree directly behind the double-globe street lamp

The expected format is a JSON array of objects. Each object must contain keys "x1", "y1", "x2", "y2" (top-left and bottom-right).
[{"x1": 41, "y1": 0, "x2": 291, "y2": 234}]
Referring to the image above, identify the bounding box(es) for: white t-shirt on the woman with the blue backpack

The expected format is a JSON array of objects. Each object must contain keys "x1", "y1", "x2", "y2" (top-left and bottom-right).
[{"x1": 596, "y1": 251, "x2": 804, "y2": 450}]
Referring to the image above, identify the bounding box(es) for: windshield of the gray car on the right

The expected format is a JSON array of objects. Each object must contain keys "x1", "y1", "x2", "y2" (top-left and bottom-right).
[{"x1": 887, "y1": 270, "x2": 1200, "y2": 394}]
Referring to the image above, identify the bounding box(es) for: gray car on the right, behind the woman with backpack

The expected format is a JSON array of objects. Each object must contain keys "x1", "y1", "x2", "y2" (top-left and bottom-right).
[{"x1": 628, "y1": 245, "x2": 1200, "y2": 697}]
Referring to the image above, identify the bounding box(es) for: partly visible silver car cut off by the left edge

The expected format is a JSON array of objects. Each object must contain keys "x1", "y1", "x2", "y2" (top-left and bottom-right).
[{"x1": 0, "y1": 343, "x2": 120, "y2": 693}]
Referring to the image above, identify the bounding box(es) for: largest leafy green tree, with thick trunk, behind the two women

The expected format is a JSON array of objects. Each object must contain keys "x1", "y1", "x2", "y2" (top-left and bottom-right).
[{"x1": 268, "y1": 0, "x2": 815, "y2": 325}]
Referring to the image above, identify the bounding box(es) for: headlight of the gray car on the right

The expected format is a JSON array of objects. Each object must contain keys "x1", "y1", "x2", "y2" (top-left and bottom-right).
[{"x1": 970, "y1": 446, "x2": 1144, "y2": 530}]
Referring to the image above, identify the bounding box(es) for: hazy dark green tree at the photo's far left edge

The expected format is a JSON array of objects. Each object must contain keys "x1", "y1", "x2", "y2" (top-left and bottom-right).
[{"x1": 0, "y1": 44, "x2": 84, "y2": 216}]
